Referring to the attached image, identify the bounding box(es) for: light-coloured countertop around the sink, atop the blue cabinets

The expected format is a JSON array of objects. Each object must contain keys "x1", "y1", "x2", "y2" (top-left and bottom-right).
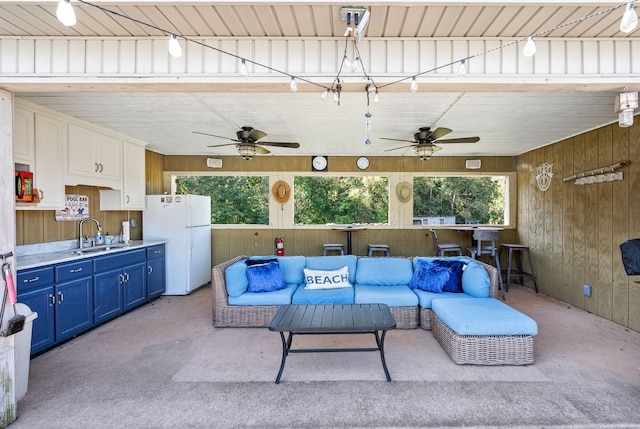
[{"x1": 16, "y1": 240, "x2": 166, "y2": 270}]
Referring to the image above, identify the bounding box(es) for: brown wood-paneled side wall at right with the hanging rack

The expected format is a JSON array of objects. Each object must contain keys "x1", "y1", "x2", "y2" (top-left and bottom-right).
[{"x1": 517, "y1": 122, "x2": 640, "y2": 331}]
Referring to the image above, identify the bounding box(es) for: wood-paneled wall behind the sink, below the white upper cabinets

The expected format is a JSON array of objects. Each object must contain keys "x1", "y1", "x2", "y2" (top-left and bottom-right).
[{"x1": 16, "y1": 186, "x2": 142, "y2": 246}]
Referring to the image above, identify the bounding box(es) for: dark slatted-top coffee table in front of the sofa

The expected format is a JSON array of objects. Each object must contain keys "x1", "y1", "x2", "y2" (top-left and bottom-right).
[{"x1": 269, "y1": 304, "x2": 396, "y2": 384}]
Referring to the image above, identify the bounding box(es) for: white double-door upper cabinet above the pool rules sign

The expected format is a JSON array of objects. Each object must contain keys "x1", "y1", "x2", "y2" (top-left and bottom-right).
[{"x1": 66, "y1": 123, "x2": 122, "y2": 189}]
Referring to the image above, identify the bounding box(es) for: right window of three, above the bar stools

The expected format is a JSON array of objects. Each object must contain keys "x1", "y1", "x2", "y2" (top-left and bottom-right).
[{"x1": 413, "y1": 176, "x2": 509, "y2": 225}]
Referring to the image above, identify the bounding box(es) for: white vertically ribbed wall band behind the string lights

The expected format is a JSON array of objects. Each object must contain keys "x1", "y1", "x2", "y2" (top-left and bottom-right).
[{"x1": 0, "y1": 37, "x2": 640, "y2": 79}]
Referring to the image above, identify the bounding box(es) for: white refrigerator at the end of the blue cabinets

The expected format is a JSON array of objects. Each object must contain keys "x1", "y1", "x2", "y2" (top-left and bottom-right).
[{"x1": 142, "y1": 195, "x2": 211, "y2": 295}]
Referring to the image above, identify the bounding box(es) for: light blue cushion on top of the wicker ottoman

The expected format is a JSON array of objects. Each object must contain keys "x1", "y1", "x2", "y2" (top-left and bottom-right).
[{"x1": 431, "y1": 298, "x2": 538, "y2": 336}]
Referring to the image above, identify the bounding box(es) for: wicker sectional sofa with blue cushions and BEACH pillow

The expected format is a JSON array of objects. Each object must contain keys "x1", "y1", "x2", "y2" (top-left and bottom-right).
[{"x1": 212, "y1": 255, "x2": 498, "y2": 329}]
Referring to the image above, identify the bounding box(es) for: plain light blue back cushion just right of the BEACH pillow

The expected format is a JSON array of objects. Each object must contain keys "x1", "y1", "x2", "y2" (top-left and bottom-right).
[{"x1": 356, "y1": 257, "x2": 413, "y2": 286}]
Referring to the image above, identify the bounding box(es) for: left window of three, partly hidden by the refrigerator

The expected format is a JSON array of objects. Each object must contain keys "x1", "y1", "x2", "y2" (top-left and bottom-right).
[{"x1": 176, "y1": 176, "x2": 269, "y2": 225}]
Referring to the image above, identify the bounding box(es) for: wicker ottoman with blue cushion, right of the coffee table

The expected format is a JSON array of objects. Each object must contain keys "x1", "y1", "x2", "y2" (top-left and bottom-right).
[{"x1": 432, "y1": 298, "x2": 538, "y2": 365}]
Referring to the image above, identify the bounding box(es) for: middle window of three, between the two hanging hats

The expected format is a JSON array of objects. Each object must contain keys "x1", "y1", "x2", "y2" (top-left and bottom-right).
[{"x1": 293, "y1": 176, "x2": 389, "y2": 225}]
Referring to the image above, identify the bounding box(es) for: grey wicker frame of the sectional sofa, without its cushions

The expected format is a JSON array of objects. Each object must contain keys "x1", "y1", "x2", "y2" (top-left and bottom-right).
[{"x1": 211, "y1": 255, "x2": 498, "y2": 329}]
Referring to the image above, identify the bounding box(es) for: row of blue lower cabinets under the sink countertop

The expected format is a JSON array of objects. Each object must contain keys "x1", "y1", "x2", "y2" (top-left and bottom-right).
[{"x1": 17, "y1": 244, "x2": 165, "y2": 355}]
